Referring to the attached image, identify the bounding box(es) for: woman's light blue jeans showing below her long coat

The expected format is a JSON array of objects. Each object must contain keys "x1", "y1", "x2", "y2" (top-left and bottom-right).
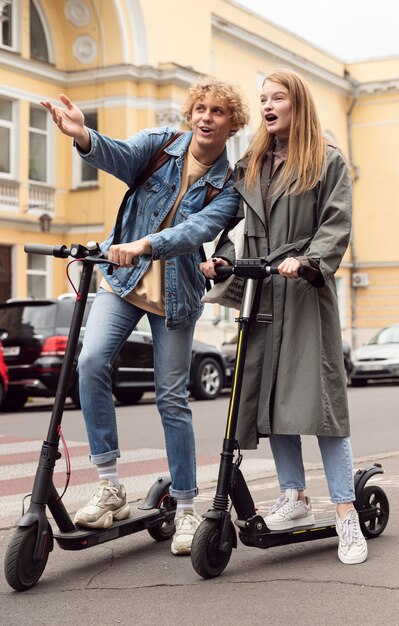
[{"x1": 270, "y1": 435, "x2": 355, "y2": 504}]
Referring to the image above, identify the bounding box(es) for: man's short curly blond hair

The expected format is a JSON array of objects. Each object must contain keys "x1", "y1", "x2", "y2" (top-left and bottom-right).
[{"x1": 182, "y1": 76, "x2": 249, "y2": 135}]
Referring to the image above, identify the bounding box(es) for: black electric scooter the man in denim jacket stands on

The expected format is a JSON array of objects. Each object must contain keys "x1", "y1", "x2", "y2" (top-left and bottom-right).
[{"x1": 4, "y1": 242, "x2": 176, "y2": 591}]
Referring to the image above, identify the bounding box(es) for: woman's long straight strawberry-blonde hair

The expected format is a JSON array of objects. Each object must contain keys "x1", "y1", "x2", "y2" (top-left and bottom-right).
[{"x1": 244, "y1": 70, "x2": 327, "y2": 195}]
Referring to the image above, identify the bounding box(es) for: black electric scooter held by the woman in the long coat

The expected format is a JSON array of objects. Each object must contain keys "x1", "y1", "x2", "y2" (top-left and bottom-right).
[{"x1": 191, "y1": 259, "x2": 389, "y2": 578}]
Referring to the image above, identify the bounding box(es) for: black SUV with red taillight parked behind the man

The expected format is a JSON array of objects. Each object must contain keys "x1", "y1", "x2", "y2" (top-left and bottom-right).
[{"x1": 0, "y1": 294, "x2": 228, "y2": 410}]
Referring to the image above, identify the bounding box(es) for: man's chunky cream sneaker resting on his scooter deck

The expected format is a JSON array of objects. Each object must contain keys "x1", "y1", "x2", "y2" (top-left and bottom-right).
[{"x1": 73, "y1": 480, "x2": 130, "y2": 528}]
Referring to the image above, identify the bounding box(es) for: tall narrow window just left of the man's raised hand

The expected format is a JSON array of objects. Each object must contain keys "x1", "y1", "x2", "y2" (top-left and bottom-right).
[{"x1": 29, "y1": 104, "x2": 48, "y2": 182}]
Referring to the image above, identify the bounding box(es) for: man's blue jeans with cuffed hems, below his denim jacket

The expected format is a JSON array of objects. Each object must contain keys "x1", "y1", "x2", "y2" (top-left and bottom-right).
[{"x1": 78, "y1": 289, "x2": 198, "y2": 500}]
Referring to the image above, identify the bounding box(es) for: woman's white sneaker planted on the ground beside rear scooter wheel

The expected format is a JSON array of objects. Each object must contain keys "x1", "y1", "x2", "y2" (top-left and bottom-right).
[{"x1": 335, "y1": 509, "x2": 367, "y2": 565}]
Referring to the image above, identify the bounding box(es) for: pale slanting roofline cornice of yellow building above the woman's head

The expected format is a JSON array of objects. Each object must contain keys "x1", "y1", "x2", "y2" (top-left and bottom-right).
[{"x1": 212, "y1": 15, "x2": 353, "y2": 95}]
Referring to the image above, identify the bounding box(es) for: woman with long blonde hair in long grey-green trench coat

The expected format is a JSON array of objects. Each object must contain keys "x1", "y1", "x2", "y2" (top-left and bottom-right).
[{"x1": 201, "y1": 70, "x2": 367, "y2": 564}]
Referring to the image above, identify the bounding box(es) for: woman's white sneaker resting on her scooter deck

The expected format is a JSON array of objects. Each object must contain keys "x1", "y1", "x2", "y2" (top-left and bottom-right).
[{"x1": 264, "y1": 489, "x2": 315, "y2": 530}]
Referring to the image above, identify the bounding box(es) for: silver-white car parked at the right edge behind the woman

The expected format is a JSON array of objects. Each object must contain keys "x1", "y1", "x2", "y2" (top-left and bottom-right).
[{"x1": 351, "y1": 324, "x2": 399, "y2": 387}]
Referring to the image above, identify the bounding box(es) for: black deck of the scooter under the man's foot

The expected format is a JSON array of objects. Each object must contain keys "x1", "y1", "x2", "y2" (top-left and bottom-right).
[{"x1": 53, "y1": 505, "x2": 170, "y2": 550}]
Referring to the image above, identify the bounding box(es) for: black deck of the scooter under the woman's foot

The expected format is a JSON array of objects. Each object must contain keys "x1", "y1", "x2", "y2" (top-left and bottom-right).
[{"x1": 235, "y1": 516, "x2": 337, "y2": 549}]
